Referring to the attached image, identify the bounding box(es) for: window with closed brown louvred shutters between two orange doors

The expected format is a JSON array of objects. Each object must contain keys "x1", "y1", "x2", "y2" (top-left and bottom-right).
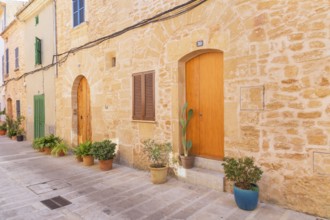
[{"x1": 133, "y1": 71, "x2": 155, "y2": 121}]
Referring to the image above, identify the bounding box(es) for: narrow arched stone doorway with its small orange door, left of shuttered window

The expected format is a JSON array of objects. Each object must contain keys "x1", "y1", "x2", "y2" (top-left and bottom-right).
[{"x1": 72, "y1": 76, "x2": 92, "y2": 144}]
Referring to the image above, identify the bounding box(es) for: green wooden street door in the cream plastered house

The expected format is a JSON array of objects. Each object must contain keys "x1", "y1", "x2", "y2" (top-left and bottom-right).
[{"x1": 34, "y1": 95, "x2": 45, "y2": 138}]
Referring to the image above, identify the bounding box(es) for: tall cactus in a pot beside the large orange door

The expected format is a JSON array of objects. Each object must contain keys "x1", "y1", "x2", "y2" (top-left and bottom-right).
[{"x1": 180, "y1": 102, "x2": 195, "y2": 169}]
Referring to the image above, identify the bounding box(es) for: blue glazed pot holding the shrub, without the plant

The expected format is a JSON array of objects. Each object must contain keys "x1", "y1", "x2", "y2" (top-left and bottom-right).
[{"x1": 234, "y1": 184, "x2": 259, "y2": 211}]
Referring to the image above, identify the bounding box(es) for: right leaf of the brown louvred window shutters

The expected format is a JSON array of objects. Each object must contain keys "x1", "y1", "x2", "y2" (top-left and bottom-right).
[{"x1": 144, "y1": 72, "x2": 155, "y2": 120}]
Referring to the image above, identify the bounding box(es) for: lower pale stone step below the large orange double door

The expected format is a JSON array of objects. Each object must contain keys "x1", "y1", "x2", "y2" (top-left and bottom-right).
[{"x1": 177, "y1": 166, "x2": 225, "y2": 192}]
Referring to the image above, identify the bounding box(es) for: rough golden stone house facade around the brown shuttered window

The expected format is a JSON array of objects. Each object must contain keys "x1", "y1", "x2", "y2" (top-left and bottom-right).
[{"x1": 56, "y1": 0, "x2": 330, "y2": 217}]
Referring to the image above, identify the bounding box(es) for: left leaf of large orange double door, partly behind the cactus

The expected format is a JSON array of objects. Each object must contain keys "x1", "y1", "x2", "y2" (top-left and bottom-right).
[{"x1": 186, "y1": 58, "x2": 200, "y2": 155}]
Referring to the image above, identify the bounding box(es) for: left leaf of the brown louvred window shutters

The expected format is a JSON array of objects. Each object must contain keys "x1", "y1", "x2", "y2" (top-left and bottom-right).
[{"x1": 133, "y1": 74, "x2": 143, "y2": 120}]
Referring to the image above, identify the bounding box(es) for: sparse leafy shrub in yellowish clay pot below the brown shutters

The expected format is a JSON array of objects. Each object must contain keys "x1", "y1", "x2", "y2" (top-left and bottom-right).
[{"x1": 143, "y1": 139, "x2": 172, "y2": 184}]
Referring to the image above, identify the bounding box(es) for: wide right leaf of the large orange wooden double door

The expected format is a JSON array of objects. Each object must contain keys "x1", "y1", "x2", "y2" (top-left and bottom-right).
[{"x1": 200, "y1": 53, "x2": 223, "y2": 159}]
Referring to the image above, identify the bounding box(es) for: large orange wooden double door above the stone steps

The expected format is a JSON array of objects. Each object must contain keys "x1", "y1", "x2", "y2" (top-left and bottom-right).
[{"x1": 186, "y1": 53, "x2": 224, "y2": 159}]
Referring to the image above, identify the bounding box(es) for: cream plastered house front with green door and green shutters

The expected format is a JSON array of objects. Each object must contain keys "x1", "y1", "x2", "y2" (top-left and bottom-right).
[{"x1": 16, "y1": 0, "x2": 57, "y2": 140}]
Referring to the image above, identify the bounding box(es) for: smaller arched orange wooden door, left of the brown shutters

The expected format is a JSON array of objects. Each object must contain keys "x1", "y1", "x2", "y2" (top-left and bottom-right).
[{"x1": 78, "y1": 78, "x2": 92, "y2": 144}]
